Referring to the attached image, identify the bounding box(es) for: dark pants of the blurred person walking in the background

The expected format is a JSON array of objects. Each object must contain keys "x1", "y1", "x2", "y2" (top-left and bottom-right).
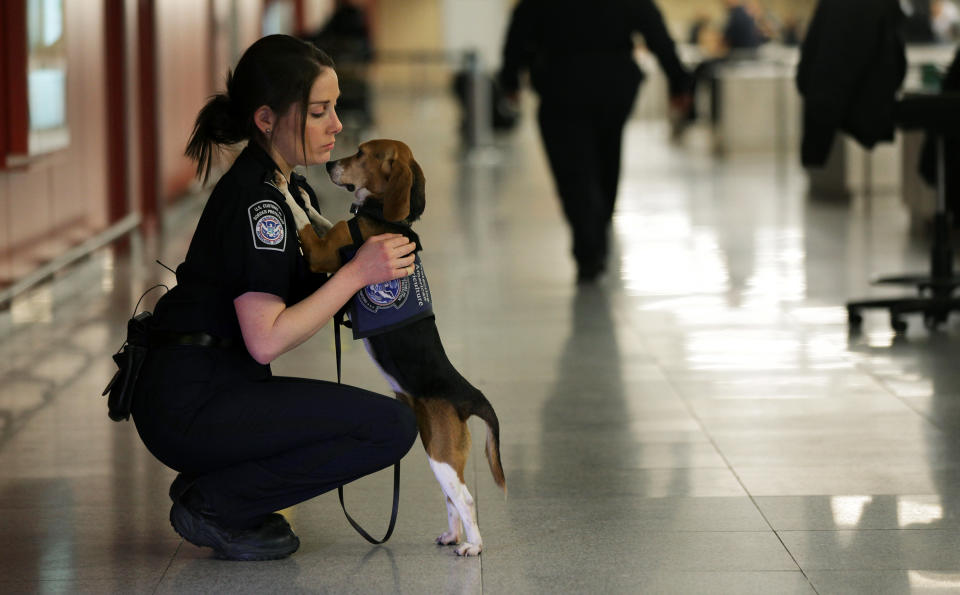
[{"x1": 537, "y1": 85, "x2": 638, "y2": 271}]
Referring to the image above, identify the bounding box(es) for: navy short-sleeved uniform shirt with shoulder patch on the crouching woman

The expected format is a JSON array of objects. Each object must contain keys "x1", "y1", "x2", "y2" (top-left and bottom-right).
[{"x1": 155, "y1": 142, "x2": 326, "y2": 352}]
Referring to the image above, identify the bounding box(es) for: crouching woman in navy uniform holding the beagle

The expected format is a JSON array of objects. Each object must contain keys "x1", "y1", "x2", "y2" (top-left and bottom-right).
[{"x1": 132, "y1": 35, "x2": 417, "y2": 560}]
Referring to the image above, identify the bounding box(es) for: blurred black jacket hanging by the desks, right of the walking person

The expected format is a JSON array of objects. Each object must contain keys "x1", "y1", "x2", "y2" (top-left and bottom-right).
[{"x1": 797, "y1": 0, "x2": 907, "y2": 167}]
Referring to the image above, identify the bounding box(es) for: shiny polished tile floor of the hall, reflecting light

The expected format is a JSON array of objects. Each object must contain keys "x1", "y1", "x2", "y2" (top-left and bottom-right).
[{"x1": 0, "y1": 89, "x2": 960, "y2": 594}]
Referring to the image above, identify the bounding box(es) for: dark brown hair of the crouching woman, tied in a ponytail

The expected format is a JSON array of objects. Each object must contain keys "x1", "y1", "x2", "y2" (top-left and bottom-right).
[{"x1": 186, "y1": 35, "x2": 333, "y2": 183}]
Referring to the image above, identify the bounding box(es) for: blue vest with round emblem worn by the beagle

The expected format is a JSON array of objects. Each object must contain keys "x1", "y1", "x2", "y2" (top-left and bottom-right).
[{"x1": 340, "y1": 209, "x2": 433, "y2": 339}]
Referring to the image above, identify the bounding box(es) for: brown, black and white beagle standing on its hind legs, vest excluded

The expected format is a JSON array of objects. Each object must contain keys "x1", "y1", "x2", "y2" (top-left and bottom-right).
[{"x1": 273, "y1": 140, "x2": 507, "y2": 556}]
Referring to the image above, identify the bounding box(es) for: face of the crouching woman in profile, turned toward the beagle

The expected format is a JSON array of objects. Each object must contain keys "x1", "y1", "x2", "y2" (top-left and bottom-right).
[{"x1": 273, "y1": 68, "x2": 343, "y2": 168}]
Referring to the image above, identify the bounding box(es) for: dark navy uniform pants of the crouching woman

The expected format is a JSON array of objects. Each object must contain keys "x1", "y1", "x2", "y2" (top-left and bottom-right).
[{"x1": 133, "y1": 347, "x2": 417, "y2": 527}]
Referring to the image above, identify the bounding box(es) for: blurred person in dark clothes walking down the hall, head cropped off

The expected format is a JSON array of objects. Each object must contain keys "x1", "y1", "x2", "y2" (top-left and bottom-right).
[{"x1": 498, "y1": 0, "x2": 691, "y2": 282}]
